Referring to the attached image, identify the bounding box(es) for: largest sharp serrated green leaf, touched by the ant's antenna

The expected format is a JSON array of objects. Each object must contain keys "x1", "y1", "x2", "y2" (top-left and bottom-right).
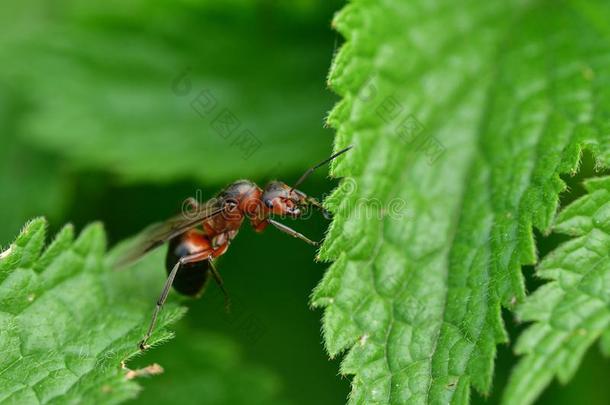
[{"x1": 312, "y1": 0, "x2": 610, "y2": 404}]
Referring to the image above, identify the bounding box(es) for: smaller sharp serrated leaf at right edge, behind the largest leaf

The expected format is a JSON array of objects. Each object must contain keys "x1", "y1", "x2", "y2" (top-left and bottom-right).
[{"x1": 504, "y1": 177, "x2": 610, "y2": 404}]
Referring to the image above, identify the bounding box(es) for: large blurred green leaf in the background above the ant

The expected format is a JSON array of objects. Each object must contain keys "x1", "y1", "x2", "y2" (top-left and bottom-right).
[{"x1": 0, "y1": 0, "x2": 333, "y2": 183}]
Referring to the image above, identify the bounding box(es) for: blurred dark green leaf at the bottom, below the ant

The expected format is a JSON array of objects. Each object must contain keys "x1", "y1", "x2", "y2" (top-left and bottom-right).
[{"x1": 129, "y1": 327, "x2": 286, "y2": 405}]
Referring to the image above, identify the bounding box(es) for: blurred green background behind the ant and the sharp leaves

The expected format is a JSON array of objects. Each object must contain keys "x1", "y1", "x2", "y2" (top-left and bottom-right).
[{"x1": 0, "y1": 0, "x2": 610, "y2": 404}]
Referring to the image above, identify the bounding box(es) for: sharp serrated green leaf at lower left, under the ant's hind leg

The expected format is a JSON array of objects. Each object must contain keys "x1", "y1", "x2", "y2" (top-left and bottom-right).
[{"x1": 0, "y1": 219, "x2": 184, "y2": 404}]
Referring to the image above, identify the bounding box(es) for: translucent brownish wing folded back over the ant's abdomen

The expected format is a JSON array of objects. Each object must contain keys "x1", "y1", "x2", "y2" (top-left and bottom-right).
[{"x1": 112, "y1": 198, "x2": 225, "y2": 268}]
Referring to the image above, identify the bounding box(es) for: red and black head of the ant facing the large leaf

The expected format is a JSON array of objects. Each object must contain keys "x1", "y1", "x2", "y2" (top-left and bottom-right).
[{"x1": 261, "y1": 181, "x2": 329, "y2": 218}]
